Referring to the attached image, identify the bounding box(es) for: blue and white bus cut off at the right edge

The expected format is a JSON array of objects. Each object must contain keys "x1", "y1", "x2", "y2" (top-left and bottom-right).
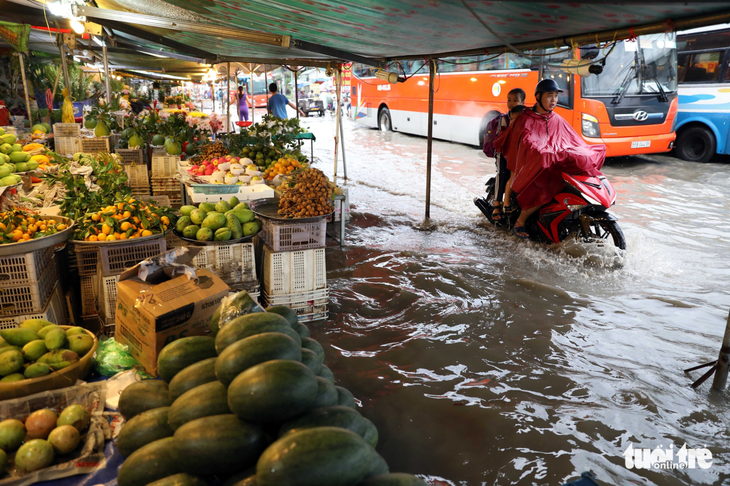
[{"x1": 675, "y1": 24, "x2": 730, "y2": 162}]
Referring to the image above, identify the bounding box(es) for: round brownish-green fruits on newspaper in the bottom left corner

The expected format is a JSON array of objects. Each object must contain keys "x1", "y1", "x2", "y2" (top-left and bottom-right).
[{"x1": 0, "y1": 404, "x2": 91, "y2": 474}]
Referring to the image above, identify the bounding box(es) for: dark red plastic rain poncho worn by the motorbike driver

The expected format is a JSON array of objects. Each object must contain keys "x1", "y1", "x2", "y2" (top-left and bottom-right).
[{"x1": 494, "y1": 108, "x2": 606, "y2": 209}]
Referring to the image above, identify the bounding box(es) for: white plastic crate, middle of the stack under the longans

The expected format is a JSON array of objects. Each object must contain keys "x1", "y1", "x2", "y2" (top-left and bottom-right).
[{"x1": 263, "y1": 245, "x2": 327, "y2": 296}]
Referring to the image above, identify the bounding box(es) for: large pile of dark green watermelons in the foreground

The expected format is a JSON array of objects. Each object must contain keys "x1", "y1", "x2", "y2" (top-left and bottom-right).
[{"x1": 112, "y1": 292, "x2": 426, "y2": 486}]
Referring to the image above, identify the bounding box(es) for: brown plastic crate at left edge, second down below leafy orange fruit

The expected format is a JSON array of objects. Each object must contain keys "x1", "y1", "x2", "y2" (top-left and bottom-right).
[{"x1": 0, "y1": 258, "x2": 58, "y2": 317}]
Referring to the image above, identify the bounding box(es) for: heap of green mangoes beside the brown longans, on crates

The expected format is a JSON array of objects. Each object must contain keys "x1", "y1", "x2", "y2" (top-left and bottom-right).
[{"x1": 175, "y1": 196, "x2": 261, "y2": 241}]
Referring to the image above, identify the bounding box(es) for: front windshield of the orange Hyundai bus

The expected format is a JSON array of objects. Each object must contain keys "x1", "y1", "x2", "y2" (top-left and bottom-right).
[{"x1": 581, "y1": 34, "x2": 677, "y2": 98}]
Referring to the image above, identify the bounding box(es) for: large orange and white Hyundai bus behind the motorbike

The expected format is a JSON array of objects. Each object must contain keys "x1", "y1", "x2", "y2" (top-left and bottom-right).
[{"x1": 351, "y1": 34, "x2": 677, "y2": 157}]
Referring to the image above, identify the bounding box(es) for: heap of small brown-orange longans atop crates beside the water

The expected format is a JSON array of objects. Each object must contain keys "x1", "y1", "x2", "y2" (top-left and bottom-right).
[{"x1": 279, "y1": 169, "x2": 334, "y2": 218}]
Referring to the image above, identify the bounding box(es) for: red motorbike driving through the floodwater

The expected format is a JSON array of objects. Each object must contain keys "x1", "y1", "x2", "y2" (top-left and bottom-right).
[{"x1": 474, "y1": 173, "x2": 626, "y2": 250}]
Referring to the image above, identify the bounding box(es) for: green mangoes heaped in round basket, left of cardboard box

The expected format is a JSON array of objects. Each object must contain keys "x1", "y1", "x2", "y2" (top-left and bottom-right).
[{"x1": 0, "y1": 319, "x2": 94, "y2": 383}]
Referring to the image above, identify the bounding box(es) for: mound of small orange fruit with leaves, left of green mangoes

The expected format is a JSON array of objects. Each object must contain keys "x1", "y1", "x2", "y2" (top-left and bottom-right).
[{"x1": 73, "y1": 198, "x2": 175, "y2": 241}]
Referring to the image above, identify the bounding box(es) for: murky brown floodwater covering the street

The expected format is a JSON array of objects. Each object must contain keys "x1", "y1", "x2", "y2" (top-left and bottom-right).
[{"x1": 292, "y1": 112, "x2": 730, "y2": 486}]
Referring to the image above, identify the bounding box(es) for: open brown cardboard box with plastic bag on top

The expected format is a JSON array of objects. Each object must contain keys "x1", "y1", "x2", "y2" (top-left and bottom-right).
[{"x1": 114, "y1": 248, "x2": 229, "y2": 376}]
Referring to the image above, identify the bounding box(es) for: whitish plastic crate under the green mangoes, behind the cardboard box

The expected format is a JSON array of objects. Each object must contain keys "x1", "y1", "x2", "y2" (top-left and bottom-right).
[{"x1": 193, "y1": 243, "x2": 259, "y2": 291}]
